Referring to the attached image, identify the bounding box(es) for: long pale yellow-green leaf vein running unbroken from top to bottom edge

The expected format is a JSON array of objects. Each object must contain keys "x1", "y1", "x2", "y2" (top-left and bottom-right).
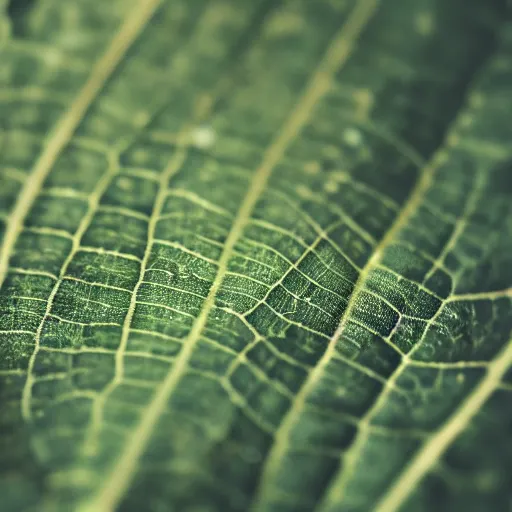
[{"x1": 79, "y1": 0, "x2": 378, "y2": 512}]
